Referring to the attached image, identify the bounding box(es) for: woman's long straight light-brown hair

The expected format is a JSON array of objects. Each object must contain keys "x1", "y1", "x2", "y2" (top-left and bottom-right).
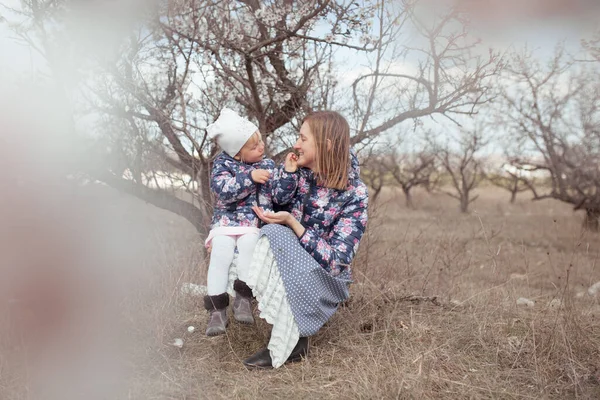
[{"x1": 302, "y1": 111, "x2": 350, "y2": 190}]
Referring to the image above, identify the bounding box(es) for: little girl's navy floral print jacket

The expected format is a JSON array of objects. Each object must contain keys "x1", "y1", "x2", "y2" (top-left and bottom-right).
[{"x1": 210, "y1": 152, "x2": 275, "y2": 229}]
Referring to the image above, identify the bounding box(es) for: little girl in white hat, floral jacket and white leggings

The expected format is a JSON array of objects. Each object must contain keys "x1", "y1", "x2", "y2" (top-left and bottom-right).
[{"x1": 204, "y1": 108, "x2": 275, "y2": 336}]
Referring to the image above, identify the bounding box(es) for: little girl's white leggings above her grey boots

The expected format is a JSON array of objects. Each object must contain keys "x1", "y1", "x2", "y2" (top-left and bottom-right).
[{"x1": 207, "y1": 233, "x2": 258, "y2": 296}]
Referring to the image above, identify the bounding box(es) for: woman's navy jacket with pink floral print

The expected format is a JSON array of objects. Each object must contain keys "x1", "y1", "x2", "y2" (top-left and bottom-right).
[{"x1": 273, "y1": 152, "x2": 368, "y2": 277}]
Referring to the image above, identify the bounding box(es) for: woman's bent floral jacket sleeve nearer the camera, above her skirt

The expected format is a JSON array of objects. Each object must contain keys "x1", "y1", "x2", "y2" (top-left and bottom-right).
[{"x1": 300, "y1": 185, "x2": 368, "y2": 276}]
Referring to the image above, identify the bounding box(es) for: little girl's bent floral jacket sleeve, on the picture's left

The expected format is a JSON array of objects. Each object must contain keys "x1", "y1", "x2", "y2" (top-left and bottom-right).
[{"x1": 210, "y1": 160, "x2": 256, "y2": 204}]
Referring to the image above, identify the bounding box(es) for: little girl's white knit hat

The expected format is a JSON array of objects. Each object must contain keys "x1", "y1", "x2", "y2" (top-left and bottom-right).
[{"x1": 206, "y1": 108, "x2": 258, "y2": 157}]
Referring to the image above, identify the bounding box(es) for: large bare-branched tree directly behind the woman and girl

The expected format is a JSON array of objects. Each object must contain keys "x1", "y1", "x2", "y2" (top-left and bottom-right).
[{"x1": 8, "y1": 0, "x2": 500, "y2": 233}]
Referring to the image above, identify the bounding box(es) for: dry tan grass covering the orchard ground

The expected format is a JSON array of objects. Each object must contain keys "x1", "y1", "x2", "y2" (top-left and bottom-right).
[{"x1": 0, "y1": 184, "x2": 600, "y2": 400}]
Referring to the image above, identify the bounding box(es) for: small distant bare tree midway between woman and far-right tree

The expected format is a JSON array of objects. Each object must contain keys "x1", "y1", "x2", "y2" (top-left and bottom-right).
[{"x1": 430, "y1": 130, "x2": 488, "y2": 213}]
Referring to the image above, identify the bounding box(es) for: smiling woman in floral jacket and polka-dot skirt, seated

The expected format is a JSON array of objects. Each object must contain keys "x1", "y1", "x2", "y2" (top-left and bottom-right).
[{"x1": 244, "y1": 111, "x2": 368, "y2": 368}]
